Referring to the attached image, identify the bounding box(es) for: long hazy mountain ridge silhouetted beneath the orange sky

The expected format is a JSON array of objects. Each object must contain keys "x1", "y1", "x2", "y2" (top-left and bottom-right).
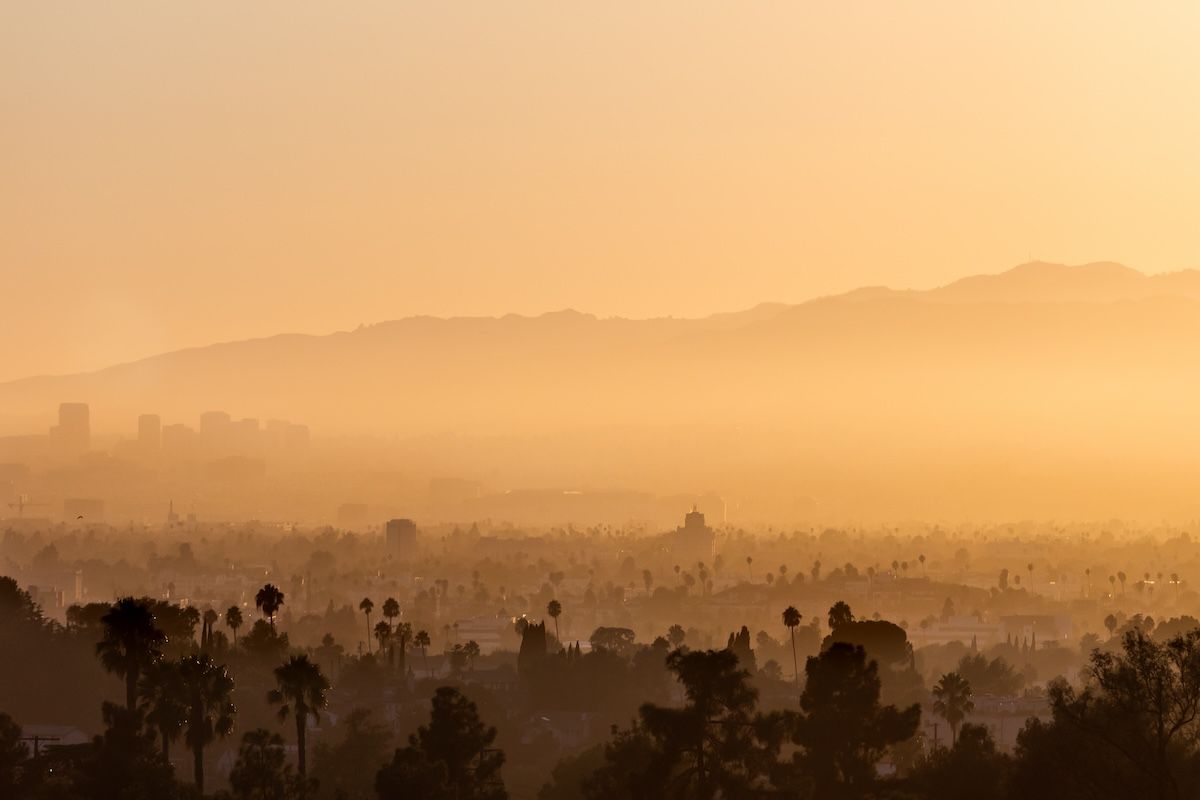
[{"x1": 0, "y1": 263, "x2": 1200, "y2": 432}]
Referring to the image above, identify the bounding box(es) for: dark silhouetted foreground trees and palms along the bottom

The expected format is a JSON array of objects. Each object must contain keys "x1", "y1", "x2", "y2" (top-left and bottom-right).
[{"x1": 7, "y1": 578, "x2": 1200, "y2": 800}]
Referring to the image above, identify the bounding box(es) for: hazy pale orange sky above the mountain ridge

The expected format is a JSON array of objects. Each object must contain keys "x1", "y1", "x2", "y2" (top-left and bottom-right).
[{"x1": 0, "y1": 0, "x2": 1200, "y2": 379}]
